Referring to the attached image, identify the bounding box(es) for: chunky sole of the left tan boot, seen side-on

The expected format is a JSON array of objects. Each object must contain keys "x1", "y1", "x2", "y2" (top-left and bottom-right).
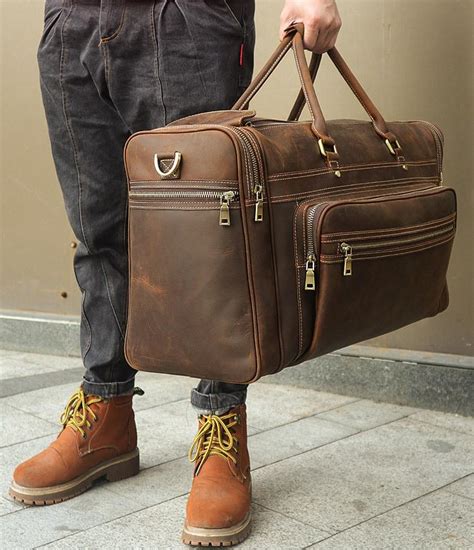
[{"x1": 8, "y1": 449, "x2": 140, "y2": 506}]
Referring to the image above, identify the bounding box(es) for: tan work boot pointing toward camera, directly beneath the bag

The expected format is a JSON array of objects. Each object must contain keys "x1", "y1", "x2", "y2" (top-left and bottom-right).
[{"x1": 182, "y1": 405, "x2": 251, "y2": 546}]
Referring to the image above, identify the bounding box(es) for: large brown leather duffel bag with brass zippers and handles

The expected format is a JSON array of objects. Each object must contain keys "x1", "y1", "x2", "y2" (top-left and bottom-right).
[{"x1": 125, "y1": 29, "x2": 456, "y2": 383}]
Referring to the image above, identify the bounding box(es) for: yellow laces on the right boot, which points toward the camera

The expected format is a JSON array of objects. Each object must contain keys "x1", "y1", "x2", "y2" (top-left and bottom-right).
[{"x1": 188, "y1": 413, "x2": 238, "y2": 475}]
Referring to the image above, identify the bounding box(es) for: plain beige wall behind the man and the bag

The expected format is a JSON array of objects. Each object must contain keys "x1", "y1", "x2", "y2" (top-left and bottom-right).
[{"x1": 0, "y1": 0, "x2": 474, "y2": 355}]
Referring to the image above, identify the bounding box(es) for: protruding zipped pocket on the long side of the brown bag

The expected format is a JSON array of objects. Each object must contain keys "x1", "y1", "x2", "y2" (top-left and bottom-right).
[{"x1": 298, "y1": 187, "x2": 456, "y2": 359}]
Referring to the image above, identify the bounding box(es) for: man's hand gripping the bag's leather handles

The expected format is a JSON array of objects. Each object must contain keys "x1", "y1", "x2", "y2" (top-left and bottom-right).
[{"x1": 280, "y1": 0, "x2": 342, "y2": 53}]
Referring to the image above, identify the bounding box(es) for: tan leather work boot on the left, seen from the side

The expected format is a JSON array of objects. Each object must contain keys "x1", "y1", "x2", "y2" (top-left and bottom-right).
[{"x1": 9, "y1": 388, "x2": 143, "y2": 505}]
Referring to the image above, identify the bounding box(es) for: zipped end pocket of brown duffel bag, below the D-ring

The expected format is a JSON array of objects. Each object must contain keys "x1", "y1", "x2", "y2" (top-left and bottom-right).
[{"x1": 125, "y1": 182, "x2": 262, "y2": 383}]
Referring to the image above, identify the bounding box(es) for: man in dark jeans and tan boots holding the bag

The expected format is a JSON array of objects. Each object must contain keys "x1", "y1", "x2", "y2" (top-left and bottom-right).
[{"x1": 10, "y1": 0, "x2": 341, "y2": 546}]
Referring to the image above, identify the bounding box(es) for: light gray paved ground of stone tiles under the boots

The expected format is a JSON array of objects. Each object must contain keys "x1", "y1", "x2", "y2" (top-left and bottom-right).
[{"x1": 0, "y1": 351, "x2": 474, "y2": 550}]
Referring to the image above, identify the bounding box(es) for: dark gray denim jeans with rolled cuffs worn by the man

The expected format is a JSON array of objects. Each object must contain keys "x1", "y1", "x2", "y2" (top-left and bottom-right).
[{"x1": 38, "y1": 0, "x2": 255, "y2": 412}]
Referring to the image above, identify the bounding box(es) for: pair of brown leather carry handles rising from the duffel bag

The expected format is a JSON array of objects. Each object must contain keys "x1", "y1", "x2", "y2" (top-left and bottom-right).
[{"x1": 233, "y1": 24, "x2": 402, "y2": 163}]
